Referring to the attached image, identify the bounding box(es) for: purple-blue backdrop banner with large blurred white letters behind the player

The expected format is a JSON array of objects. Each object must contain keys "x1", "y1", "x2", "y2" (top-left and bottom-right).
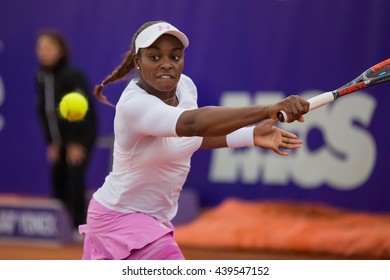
[{"x1": 0, "y1": 0, "x2": 390, "y2": 212}]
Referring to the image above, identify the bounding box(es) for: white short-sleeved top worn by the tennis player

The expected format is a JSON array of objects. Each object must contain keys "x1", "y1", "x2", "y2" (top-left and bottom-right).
[{"x1": 93, "y1": 74, "x2": 202, "y2": 222}]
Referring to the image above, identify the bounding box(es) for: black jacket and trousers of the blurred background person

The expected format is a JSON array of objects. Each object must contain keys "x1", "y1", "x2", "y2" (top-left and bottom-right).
[{"x1": 36, "y1": 57, "x2": 97, "y2": 230}]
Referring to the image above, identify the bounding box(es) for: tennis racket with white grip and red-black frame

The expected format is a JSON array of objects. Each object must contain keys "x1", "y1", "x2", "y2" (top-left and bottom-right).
[{"x1": 277, "y1": 59, "x2": 390, "y2": 122}]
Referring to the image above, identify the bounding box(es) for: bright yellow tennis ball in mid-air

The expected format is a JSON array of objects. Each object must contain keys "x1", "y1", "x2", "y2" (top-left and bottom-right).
[{"x1": 59, "y1": 92, "x2": 88, "y2": 122}]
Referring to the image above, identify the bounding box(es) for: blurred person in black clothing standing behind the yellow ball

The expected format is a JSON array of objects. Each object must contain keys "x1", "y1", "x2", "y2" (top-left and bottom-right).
[{"x1": 35, "y1": 29, "x2": 97, "y2": 236}]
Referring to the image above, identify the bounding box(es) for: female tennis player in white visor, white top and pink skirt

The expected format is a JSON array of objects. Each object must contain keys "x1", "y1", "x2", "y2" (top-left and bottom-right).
[{"x1": 80, "y1": 21, "x2": 309, "y2": 259}]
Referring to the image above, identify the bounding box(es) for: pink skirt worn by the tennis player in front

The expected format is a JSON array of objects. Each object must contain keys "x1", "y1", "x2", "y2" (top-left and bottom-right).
[{"x1": 79, "y1": 198, "x2": 174, "y2": 260}]
